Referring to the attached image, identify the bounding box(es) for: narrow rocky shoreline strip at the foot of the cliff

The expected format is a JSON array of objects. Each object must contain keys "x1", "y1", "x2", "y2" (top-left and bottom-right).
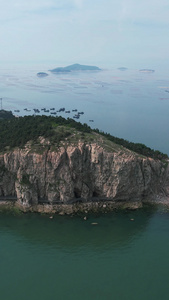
[{"x1": 0, "y1": 198, "x2": 169, "y2": 215}]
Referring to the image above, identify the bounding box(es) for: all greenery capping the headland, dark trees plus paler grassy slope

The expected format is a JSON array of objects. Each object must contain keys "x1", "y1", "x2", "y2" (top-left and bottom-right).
[{"x1": 0, "y1": 116, "x2": 168, "y2": 160}]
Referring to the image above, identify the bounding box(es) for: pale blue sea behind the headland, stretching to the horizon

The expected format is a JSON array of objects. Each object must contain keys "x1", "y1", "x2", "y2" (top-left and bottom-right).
[{"x1": 0, "y1": 66, "x2": 169, "y2": 154}]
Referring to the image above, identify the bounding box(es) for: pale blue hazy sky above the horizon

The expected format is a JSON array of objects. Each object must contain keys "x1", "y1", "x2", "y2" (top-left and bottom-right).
[{"x1": 0, "y1": 0, "x2": 169, "y2": 68}]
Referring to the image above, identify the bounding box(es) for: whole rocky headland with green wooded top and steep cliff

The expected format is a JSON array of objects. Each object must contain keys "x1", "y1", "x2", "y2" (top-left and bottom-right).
[{"x1": 0, "y1": 116, "x2": 169, "y2": 214}]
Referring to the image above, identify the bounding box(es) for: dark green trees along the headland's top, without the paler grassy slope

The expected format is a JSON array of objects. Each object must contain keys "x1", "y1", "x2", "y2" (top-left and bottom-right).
[{"x1": 0, "y1": 116, "x2": 168, "y2": 160}]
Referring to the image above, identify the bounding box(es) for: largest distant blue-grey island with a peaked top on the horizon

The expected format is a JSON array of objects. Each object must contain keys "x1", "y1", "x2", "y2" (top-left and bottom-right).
[{"x1": 49, "y1": 64, "x2": 101, "y2": 73}]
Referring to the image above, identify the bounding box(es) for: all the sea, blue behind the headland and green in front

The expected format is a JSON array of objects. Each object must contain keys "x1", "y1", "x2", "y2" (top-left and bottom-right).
[{"x1": 0, "y1": 66, "x2": 169, "y2": 300}]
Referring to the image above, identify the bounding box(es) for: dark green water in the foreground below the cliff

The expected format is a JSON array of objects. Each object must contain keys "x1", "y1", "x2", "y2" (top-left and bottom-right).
[{"x1": 0, "y1": 207, "x2": 169, "y2": 300}]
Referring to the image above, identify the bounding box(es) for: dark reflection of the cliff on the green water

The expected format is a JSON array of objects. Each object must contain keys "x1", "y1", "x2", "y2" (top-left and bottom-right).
[{"x1": 0, "y1": 207, "x2": 160, "y2": 252}]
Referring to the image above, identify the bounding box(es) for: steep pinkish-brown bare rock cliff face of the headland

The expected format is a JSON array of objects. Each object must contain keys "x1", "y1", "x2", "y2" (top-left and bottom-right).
[{"x1": 0, "y1": 142, "x2": 169, "y2": 206}]
